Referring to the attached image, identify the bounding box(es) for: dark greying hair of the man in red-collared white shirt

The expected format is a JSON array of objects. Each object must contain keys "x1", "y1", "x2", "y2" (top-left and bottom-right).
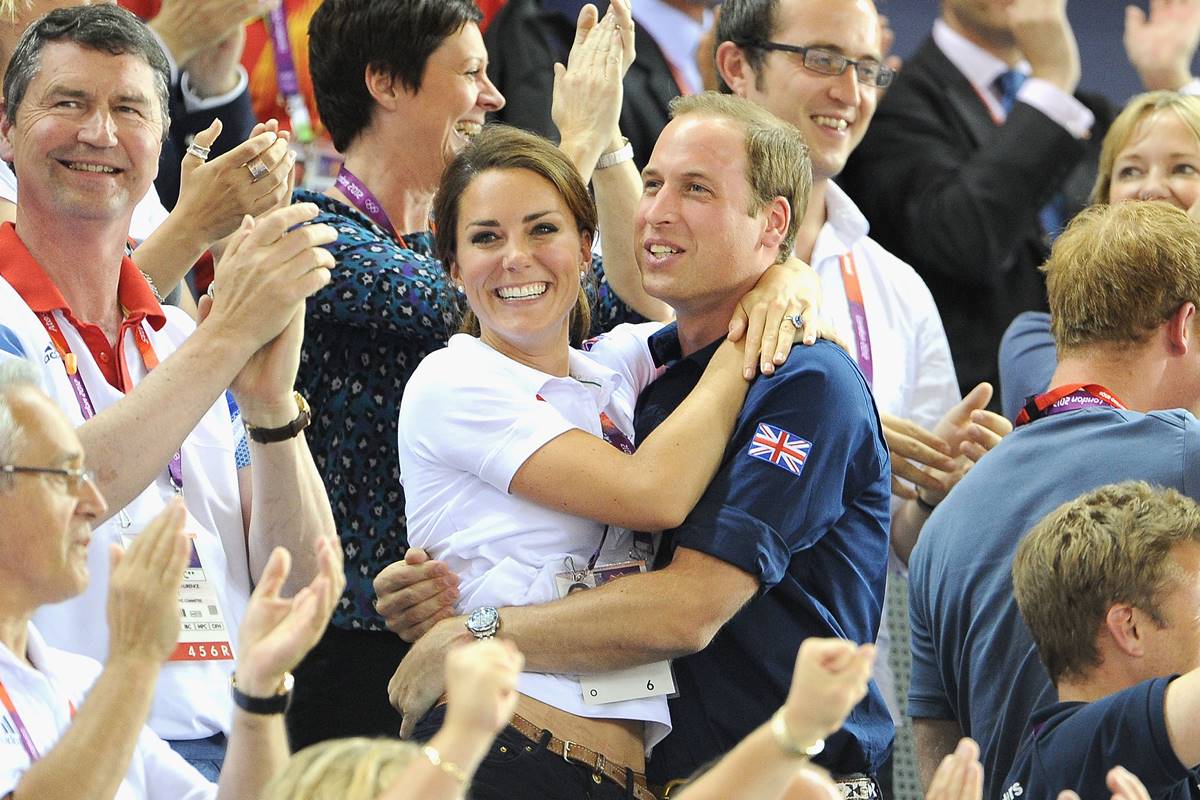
[{"x1": 4, "y1": 5, "x2": 170, "y2": 142}]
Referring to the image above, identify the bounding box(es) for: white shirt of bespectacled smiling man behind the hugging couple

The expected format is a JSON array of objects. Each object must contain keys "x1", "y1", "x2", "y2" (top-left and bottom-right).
[{"x1": 812, "y1": 181, "x2": 961, "y2": 722}]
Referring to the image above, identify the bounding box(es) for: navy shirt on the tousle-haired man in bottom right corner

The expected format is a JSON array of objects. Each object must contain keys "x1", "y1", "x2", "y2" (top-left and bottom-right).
[{"x1": 1002, "y1": 675, "x2": 1200, "y2": 800}]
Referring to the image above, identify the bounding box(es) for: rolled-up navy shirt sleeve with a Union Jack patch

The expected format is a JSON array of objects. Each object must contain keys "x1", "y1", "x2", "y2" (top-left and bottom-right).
[{"x1": 674, "y1": 342, "x2": 889, "y2": 591}]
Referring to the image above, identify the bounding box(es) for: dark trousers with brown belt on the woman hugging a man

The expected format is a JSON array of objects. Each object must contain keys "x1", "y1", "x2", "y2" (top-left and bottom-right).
[{"x1": 414, "y1": 705, "x2": 634, "y2": 800}]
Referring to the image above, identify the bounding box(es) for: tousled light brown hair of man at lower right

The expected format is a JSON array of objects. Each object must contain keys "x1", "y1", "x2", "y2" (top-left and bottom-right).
[{"x1": 1013, "y1": 481, "x2": 1200, "y2": 685}]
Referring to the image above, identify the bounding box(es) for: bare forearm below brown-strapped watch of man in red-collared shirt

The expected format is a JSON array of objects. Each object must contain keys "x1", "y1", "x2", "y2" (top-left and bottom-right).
[{"x1": 246, "y1": 434, "x2": 337, "y2": 595}]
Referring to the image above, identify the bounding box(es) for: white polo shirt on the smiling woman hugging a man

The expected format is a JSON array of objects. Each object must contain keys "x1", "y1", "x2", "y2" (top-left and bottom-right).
[{"x1": 398, "y1": 323, "x2": 671, "y2": 750}]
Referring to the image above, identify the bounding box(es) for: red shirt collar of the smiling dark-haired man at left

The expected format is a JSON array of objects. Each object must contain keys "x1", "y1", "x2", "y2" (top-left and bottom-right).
[{"x1": 0, "y1": 222, "x2": 167, "y2": 331}]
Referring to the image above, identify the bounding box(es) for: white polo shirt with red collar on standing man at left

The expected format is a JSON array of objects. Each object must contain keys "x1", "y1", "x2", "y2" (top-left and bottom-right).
[{"x1": 0, "y1": 223, "x2": 250, "y2": 739}]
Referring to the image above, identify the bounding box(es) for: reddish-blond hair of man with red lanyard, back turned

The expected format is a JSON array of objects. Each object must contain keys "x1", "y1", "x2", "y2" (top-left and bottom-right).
[{"x1": 1042, "y1": 200, "x2": 1200, "y2": 351}]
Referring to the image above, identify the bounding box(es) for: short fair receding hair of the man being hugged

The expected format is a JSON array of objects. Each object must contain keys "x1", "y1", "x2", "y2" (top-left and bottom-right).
[{"x1": 671, "y1": 91, "x2": 812, "y2": 261}]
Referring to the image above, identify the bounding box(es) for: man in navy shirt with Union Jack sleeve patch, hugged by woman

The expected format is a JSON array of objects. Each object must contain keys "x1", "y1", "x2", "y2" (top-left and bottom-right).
[{"x1": 392, "y1": 94, "x2": 893, "y2": 796}]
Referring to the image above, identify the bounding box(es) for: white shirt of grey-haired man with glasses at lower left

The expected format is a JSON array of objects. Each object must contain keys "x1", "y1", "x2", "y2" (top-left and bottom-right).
[{"x1": 0, "y1": 625, "x2": 217, "y2": 800}]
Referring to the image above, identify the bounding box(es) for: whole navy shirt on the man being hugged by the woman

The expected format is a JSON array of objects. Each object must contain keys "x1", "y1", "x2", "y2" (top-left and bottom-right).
[{"x1": 635, "y1": 325, "x2": 893, "y2": 783}]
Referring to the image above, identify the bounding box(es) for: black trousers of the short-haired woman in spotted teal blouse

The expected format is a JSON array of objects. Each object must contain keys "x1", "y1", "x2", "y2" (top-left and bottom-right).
[{"x1": 287, "y1": 625, "x2": 408, "y2": 751}]
